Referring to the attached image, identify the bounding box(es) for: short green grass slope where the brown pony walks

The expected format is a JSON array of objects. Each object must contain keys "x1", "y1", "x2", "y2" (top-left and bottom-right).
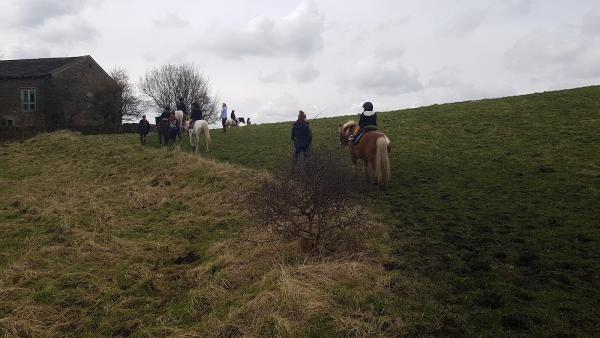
[{"x1": 164, "y1": 86, "x2": 600, "y2": 336}]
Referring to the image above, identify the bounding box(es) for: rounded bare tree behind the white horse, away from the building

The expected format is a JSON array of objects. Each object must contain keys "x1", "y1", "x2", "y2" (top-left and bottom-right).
[{"x1": 140, "y1": 64, "x2": 218, "y2": 123}]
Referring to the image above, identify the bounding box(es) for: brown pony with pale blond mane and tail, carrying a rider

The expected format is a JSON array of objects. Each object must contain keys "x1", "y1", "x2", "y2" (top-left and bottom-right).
[{"x1": 338, "y1": 121, "x2": 391, "y2": 187}]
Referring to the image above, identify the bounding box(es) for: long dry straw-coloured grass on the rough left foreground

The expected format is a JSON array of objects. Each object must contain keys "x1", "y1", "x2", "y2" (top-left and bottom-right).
[{"x1": 0, "y1": 131, "x2": 432, "y2": 337}]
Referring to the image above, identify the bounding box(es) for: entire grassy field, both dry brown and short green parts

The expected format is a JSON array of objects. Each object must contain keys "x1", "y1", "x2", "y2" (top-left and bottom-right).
[{"x1": 0, "y1": 87, "x2": 600, "y2": 337}]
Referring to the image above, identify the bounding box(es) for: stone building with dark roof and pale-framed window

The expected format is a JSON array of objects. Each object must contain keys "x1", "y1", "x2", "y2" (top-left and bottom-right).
[{"x1": 0, "y1": 55, "x2": 122, "y2": 130}]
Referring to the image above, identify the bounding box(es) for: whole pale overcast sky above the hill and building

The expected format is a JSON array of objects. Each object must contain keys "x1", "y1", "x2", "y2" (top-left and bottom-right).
[{"x1": 0, "y1": 0, "x2": 600, "y2": 122}]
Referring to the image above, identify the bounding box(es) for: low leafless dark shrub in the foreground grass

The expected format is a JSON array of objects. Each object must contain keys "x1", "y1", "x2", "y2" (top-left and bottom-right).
[{"x1": 249, "y1": 150, "x2": 370, "y2": 254}]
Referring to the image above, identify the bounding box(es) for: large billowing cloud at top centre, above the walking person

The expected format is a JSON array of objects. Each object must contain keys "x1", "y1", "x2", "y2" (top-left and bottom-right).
[{"x1": 201, "y1": 2, "x2": 325, "y2": 58}]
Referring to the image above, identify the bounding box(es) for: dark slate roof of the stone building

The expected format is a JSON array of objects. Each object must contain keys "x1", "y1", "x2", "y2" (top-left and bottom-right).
[{"x1": 0, "y1": 56, "x2": 85, "y2": 79}]
